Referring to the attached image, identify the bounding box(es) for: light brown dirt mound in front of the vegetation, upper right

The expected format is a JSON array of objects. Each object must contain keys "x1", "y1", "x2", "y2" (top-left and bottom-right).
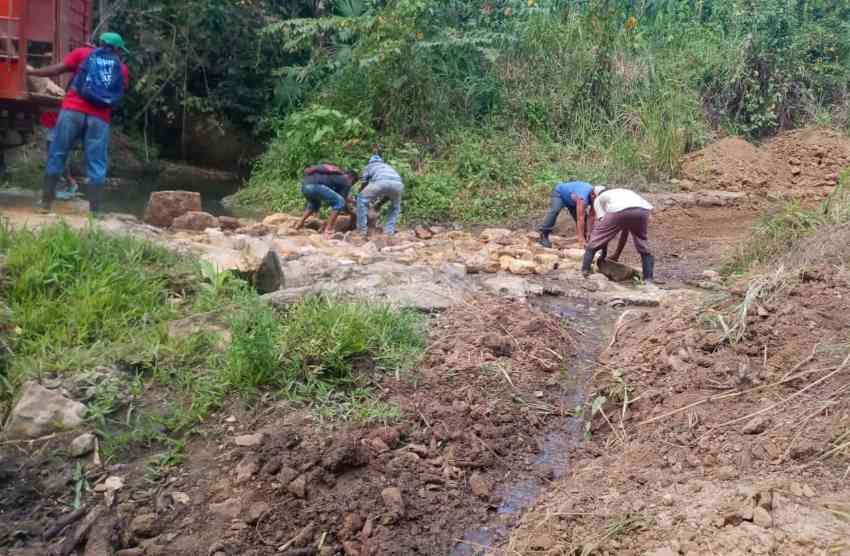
[{"x1": 682, "y1": 128, "x2": 850, "y2": 193}]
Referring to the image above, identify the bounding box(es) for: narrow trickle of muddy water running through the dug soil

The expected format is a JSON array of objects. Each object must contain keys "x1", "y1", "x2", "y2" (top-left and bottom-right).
[{"x1": 451, "y1": 297, "x2": 616, "y2": 556}]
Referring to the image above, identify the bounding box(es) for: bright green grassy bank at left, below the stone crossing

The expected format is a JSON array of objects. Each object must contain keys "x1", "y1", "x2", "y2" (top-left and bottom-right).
[{"x1": 0, "y1": 224, "x2": 425, "y2": 460}]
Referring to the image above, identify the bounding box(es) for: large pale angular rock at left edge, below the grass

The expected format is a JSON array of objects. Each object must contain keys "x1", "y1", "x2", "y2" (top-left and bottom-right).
[{"x1": 5, "y1": 381, "x2": 86, "y2": 440}]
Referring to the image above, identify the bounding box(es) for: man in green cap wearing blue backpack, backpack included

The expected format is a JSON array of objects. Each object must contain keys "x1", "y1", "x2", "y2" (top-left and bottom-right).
[{"x1": 27, "y1": 33, "x2": 130, "y2": 215}]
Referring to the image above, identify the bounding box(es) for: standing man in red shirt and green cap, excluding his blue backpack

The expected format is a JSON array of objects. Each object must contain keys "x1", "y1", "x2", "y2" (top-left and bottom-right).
[{"x1": 28, "y1": 33, "x2": 130, "y2": 215}]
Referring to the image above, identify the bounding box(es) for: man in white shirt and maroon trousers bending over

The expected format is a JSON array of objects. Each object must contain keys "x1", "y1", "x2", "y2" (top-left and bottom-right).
[{"x1": 581, "y1": 187, "x2": 655, "y2": 282}]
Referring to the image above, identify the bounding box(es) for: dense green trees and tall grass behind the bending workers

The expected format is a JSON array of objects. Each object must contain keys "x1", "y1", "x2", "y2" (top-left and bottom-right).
[{"x1": 109, "y1": 0, "x2": 850, "y2": 224}]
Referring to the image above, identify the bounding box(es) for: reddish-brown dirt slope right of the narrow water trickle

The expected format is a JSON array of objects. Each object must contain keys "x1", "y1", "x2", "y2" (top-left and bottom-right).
[{"x1": 509, "y1": 238, "x2": 850, "y2": 555}]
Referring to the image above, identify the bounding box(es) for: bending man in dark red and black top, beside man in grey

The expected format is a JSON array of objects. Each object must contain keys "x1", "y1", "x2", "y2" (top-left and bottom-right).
[{"x1": 295, "y1": 164, "x2": 358, "y2": 237}]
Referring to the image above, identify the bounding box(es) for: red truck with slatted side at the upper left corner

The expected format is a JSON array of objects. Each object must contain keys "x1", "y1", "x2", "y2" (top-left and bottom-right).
[{"x1": 0, "y1": 0, "x2": 96, "y2": 143}]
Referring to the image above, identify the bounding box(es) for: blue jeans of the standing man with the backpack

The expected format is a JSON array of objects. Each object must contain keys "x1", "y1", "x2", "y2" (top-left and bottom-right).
[{"x1": 47, "y1": 110, "x2": 110, "y2": 188}]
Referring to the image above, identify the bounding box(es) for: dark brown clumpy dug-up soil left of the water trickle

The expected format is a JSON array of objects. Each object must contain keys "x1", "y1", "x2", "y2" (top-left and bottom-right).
[{"x1": 0, "y1": 297, "x2": 588, "y2": 556}]
